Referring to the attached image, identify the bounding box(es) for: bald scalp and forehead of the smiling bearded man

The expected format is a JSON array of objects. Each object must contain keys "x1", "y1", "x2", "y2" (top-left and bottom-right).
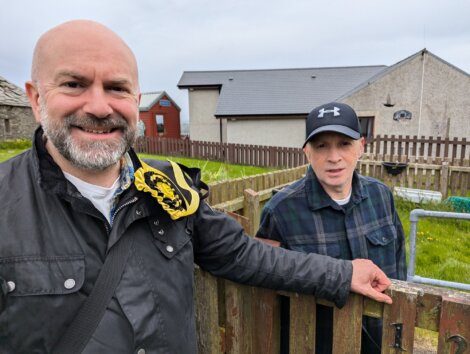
[{"x1": 31, "y1": 20, "x2": 138, "y2": 83}]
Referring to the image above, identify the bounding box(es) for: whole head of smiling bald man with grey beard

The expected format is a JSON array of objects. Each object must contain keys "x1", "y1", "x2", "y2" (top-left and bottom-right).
[{"x1": 26, "y1": 20, "x2": 139, "y2": 170}]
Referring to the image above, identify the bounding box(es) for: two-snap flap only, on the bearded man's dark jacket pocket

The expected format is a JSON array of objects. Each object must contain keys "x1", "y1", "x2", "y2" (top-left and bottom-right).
[{"x1": 0, "y1": 255, "x2": 85, "y2": 297}]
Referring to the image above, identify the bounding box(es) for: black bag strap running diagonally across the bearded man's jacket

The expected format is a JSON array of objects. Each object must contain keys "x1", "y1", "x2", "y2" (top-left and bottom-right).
[{"x1": 52, "y1": 235, "x2": 134, "y2": 354}]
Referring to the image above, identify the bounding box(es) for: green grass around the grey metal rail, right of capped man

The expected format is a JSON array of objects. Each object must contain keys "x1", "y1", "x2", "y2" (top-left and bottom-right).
[{"x1": 396, "y1": 198, "x2": 470, "y2": 283}]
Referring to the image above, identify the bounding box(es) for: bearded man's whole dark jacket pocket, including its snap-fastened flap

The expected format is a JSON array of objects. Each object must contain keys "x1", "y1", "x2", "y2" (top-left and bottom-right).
[{"x1": 0, "y1": 255, "x2": 85, "y2": 353}]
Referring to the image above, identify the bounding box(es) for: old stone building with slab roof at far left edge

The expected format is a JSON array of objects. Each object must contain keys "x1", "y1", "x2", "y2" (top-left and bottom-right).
[{"x1": 0, "y1": 76, "x2": 37, "y2": 140}]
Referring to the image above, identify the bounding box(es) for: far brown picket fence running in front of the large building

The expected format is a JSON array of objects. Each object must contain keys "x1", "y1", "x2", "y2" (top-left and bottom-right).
[{"x1": 135, "y1": 135, "x2": 470, "y2": 167}]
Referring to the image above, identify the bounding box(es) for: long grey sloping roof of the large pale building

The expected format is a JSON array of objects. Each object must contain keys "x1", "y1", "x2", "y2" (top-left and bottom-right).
[{"x1": 178, "y1": 65, "x2": 386, "y2": 117}]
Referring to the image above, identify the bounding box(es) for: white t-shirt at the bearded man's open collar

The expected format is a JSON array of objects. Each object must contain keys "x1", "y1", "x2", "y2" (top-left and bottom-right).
[{"x1": 64, "y1": 172, "x2": 119, "y2": 223}]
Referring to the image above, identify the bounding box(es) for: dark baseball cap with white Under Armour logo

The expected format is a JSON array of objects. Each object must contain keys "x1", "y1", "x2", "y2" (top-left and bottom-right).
[{"x1": 302, "y1": 102, "x2": 361, "y2": 147}]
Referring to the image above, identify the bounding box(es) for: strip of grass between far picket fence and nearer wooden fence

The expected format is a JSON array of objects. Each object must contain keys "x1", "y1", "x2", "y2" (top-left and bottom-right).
[{"x1": 139, "y1": 154, "x2": 275, "y2": 183}]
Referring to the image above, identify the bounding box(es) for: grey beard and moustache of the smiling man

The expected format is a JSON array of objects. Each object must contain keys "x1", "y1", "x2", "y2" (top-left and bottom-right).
[{"x1": 40, "y1": 104, "x2": 136, "y2": 171}]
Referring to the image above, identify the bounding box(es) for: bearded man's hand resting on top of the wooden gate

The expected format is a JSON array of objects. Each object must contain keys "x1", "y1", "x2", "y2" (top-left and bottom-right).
[{"x1": 351, "y1": 259, "x2": 392, "y2": 304}]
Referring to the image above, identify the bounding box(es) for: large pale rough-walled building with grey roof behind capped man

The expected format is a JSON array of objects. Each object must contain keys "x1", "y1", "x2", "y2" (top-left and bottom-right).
[{"x1": 178, "y1": 49, "x2": 470, "y2": 147}]
